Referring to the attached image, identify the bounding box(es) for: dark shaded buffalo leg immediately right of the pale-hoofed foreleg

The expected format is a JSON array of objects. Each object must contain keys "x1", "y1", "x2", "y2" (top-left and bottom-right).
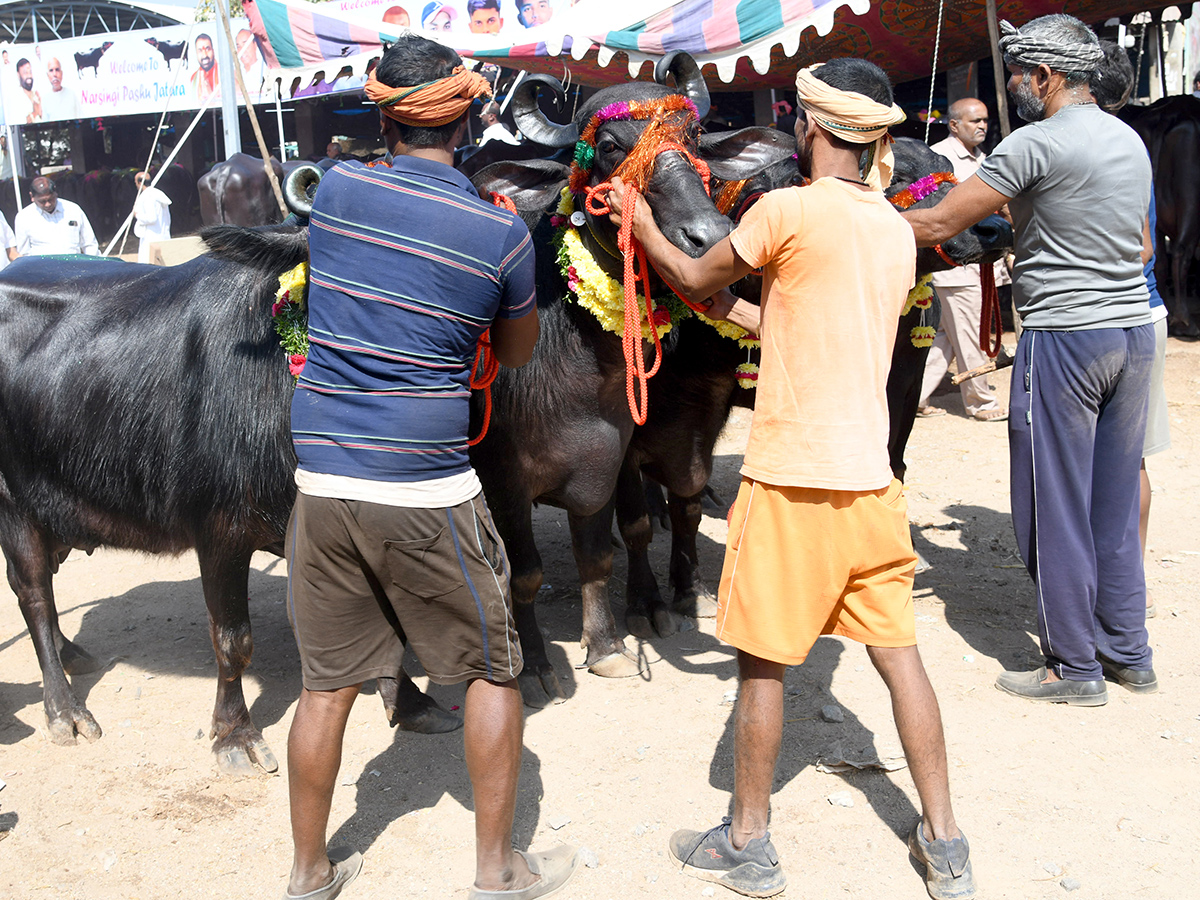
[{"x1": 616, "y1": 457, "x2": 679, "y2": 640}]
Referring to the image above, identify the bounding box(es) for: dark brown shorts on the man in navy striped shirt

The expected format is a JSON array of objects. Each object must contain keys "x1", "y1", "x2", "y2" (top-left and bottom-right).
[{"x1": 286, "y1": 493, "x2": 522, "y2": 690}]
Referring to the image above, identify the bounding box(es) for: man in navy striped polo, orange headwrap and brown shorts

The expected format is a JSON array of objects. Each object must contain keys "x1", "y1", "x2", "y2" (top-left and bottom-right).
[{"x1": 287, "y1": 35, "x2": 576, "y2": 900}]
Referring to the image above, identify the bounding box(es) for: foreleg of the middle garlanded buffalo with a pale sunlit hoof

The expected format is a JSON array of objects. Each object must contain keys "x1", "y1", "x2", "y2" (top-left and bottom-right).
[{"x1": 568, "y1": 508, "x2": 642, "y2": 678}]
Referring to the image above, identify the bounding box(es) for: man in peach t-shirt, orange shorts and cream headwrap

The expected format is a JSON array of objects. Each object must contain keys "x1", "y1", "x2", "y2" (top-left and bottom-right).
[{"x1": 608, "y1": 59, "x2": 974, "y2": 899}]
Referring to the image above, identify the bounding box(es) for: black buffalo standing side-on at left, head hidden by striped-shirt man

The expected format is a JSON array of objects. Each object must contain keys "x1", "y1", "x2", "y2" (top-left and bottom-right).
[{"x1": 0, "y1": 227, "x2": 457, "y2": 773}]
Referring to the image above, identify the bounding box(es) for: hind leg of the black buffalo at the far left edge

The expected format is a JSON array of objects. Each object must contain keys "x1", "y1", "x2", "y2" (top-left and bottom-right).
[{"x1": 2, "y1": 514, "x2": 103, "y2": 745}]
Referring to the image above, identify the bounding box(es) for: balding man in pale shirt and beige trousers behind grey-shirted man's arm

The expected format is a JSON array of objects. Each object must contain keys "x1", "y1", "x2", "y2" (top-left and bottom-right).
[{"x1": 917, "y1": 97, "x2": 1009, "y2": 422}]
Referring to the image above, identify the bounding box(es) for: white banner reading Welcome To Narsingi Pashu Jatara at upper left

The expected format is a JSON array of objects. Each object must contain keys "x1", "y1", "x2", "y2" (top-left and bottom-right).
[{"x1": 0, "y1": 19, "x2": 275, "y2": 125}]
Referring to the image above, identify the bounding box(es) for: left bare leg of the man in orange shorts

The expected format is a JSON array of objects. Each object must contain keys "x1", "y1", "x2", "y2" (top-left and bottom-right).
[{"x1": 730, "y1": 650, "x2": 785, "y2": 850}]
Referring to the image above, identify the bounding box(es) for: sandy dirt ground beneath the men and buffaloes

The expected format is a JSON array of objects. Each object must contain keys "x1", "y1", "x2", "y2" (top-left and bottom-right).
[{"x1": 0, "y1": 340, "x2": 1200, "y2": 900}]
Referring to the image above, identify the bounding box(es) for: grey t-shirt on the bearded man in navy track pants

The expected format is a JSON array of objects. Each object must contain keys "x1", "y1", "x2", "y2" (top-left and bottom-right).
[{"x1": 978, "y1": 103, "x2": 1151, "y2": 331}]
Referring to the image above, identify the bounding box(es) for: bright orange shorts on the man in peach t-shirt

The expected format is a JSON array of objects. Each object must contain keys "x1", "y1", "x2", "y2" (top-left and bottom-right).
[{"x1": 716, "y1": 478, "x2": 917, "y2": 665}]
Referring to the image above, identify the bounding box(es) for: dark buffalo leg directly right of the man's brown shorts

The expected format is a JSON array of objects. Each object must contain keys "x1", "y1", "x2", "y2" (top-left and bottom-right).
[{"x1": 490, "y1": 504, "x2": 566, "y2": 709}]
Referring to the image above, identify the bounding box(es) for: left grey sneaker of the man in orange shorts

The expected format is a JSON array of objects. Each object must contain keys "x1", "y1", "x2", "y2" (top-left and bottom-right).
[{"x1": 671, "y1": 816, "x2": 787, "y2": 896}]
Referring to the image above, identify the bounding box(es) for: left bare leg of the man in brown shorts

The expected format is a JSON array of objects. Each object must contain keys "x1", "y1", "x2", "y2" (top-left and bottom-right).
[{"x1": 288, "y1": 684, "x2": 361, "y2": 895}]
